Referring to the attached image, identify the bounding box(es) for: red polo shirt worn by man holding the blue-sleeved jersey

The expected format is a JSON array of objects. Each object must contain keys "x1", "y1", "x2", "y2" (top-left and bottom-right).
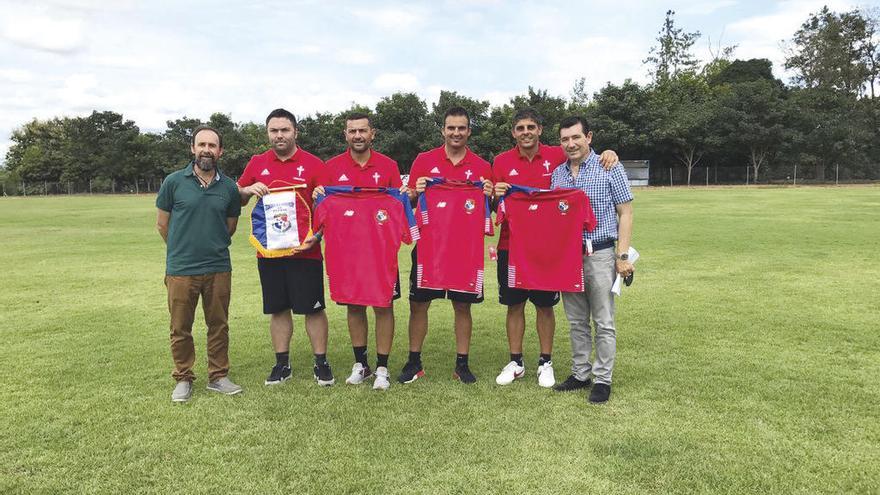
[{"x1": 321, "y1": 149, "x2": 403, "y2": 188}]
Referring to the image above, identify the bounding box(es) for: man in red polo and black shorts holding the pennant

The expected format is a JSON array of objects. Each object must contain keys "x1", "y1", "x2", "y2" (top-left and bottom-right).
[{"x1": 238, "y1": 108, "x2": 334, "y2": 386}]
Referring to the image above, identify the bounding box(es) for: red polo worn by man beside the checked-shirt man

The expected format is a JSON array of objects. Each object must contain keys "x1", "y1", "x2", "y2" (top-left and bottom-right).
[{"x1": 492, "y1": 144, "x2": 568, "y2": 250}]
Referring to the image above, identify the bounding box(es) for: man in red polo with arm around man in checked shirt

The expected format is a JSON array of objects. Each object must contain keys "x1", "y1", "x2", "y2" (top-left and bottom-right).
[{"x1": 492, "y1": 108, "x2": 618, "y2": 387}]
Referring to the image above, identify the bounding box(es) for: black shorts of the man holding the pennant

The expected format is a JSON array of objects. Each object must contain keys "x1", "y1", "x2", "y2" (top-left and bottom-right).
[{"x1": 257, "y1": 258, "x2": 326, "y2": 315}]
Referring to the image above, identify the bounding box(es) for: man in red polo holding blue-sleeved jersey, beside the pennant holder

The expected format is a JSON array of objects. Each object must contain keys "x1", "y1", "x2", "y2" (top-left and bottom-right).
[{"x1": 313, "y1": 113, "x2": 405, "y2": 390}]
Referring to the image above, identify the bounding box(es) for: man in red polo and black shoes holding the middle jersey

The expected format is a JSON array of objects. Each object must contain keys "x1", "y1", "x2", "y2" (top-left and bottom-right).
[{"x1": 398, "y1": 107, "x2": 493, "y2": 383}]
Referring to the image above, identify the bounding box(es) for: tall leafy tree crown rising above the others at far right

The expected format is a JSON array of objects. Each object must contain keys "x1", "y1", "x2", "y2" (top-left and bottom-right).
[{"x1": 785, "y1": 6, "x2": 878, "y2": 96}]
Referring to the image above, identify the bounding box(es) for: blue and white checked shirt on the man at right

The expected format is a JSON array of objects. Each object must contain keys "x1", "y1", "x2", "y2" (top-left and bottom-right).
[{"x1": 550, "y1": 150, "x2": 633, "y2": 245}]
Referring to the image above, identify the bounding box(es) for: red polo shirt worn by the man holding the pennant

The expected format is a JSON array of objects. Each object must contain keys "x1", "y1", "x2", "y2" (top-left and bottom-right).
[{"x1": 238, "y1": 147, "x2": 325, "y2": 260}]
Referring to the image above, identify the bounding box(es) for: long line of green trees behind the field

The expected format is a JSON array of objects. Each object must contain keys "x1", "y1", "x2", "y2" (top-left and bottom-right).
[{"x1": 0, "y1": 7, "x2": 880, "y2": 194}]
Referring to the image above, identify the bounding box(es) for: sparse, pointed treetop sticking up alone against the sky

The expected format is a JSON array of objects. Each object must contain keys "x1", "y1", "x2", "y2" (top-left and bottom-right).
[{"x1": 642, "y1": 10, "x2": 700, "y2": 85}]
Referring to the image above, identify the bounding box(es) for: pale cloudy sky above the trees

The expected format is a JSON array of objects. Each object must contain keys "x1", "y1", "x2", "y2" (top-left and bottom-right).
[{"x1": 0, "y1": 0, "x2": 880, "y2": 167}]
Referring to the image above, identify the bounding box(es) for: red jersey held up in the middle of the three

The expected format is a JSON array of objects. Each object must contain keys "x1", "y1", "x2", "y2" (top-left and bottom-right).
[{"x1": 416, "y1": 179, "x2": 493, "y2": 294}]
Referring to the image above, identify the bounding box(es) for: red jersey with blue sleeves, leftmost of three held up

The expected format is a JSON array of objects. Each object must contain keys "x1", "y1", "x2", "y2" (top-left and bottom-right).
[{"x1": 314, "y1": 187, "x2": 419, "y2": 307}]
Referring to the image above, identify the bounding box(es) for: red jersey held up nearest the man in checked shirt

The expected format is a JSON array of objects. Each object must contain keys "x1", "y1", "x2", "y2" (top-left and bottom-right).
[{"x1": 496, "y1": 186, "x2": 596, "y2": 292}]
